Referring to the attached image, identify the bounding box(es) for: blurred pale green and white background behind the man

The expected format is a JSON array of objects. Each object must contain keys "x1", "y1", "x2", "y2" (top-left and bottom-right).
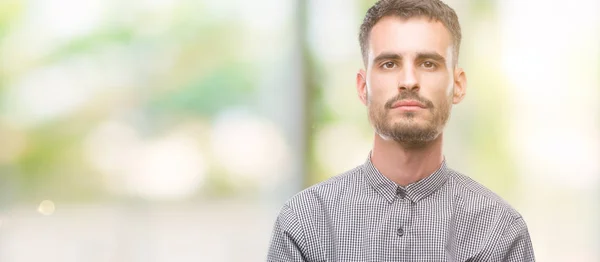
[{"x1": 0, "y1": 0, "x2": 600, "y2": 262}]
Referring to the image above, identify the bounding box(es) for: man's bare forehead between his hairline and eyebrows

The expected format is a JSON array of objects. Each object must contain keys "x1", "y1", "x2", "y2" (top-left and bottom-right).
[{"x1": 369, "y1": 16, "x2": 452, "y2": 59}]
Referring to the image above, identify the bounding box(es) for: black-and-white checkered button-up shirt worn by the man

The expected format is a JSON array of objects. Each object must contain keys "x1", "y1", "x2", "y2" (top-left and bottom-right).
[{"x1": 267, "y1": 158, "x2": 535, "y2": 262}]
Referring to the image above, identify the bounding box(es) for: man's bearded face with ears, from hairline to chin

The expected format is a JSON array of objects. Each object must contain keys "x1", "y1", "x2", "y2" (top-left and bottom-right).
[{"x1": 357, "y1": 16, "x2": 466, "y2": 145}]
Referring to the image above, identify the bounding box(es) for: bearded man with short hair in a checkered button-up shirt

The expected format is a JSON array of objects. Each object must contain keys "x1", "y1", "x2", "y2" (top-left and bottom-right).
[{"x1": 268, "y1": 0, "x2": 535, "y2": 262}]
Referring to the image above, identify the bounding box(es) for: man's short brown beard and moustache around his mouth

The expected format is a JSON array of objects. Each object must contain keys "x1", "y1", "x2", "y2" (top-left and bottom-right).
[{"x1": 367, "y1": 91, "x2": 451, "y2": 147}]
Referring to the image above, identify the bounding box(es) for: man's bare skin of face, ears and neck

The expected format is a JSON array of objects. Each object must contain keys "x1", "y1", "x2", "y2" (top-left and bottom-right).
[{"x1": 356, "y1": 16, "x2": 467, "y2": 186}]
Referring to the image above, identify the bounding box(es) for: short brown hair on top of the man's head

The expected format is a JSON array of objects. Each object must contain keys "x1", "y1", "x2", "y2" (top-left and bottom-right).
[{"x1": 359, "y1": 0, "x2": 462, "y2": 65}]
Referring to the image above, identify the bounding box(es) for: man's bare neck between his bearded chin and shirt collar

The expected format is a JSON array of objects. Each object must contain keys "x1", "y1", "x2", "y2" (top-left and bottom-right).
[{"x1": 371, "y1": 134, "x2": 443, "y2": 186}]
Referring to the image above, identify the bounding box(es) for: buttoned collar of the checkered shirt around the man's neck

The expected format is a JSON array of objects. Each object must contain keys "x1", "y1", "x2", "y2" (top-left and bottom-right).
[{"x1": 363, "y1": 154, "x2": 450, "y2": 203}]
